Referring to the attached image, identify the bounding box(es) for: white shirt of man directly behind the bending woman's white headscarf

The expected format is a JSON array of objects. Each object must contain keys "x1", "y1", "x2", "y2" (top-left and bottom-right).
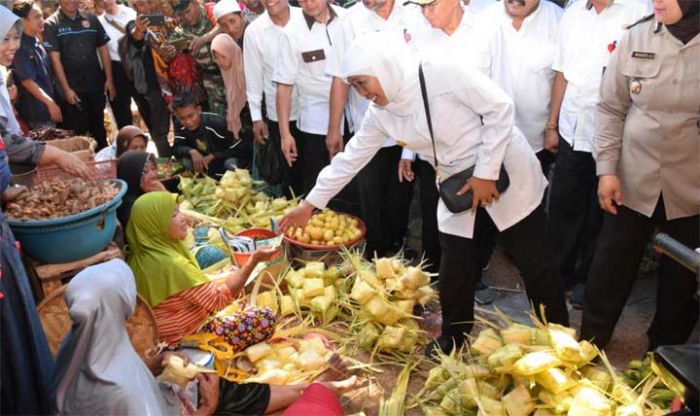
[{"x1": 326, "y1": 0, "x2": 430, "y2": 141}]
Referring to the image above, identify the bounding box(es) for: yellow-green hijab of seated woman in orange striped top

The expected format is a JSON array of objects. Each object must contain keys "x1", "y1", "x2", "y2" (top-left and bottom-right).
[{"x1": 126, "y1": 192, "x2": 210, "y2": 306}]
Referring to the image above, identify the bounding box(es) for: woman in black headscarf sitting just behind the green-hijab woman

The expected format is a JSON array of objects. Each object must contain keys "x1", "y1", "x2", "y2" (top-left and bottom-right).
[{"x1": 117, "y1": 150, "x2": 166, "y2": 229}]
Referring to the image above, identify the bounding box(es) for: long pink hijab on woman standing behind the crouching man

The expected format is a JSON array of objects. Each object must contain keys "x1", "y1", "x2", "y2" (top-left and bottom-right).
[{"x1": 211, "y1": 33, "x2": 247, "y2": 139}]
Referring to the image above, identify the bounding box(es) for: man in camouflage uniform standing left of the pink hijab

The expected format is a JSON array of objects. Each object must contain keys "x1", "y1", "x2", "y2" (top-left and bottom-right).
[{"x1": 165, "y1": 0, "x2": 226, "y2": 117}]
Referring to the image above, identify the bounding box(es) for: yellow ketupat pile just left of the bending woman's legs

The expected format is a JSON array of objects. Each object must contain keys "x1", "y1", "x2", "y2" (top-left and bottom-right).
[{"x1": 346, "y1": 252, "x2": 436, "y2": 354}]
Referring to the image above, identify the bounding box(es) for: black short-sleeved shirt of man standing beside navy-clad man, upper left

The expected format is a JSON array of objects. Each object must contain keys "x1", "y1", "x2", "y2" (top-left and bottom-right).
[{"x1": 44, "y1": 9, "x2": 109, "y2": 93}]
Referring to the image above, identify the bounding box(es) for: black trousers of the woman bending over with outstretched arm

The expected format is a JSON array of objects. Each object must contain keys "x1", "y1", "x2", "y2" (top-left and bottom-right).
[{"x1": 438, "y1": 205, "x2": 569, "y2": 338}]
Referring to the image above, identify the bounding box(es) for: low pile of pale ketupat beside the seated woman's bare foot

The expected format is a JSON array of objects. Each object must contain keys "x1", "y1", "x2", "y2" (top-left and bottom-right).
[{"x1": 245, "y1": 337, "x2": 332, "y2": 385}]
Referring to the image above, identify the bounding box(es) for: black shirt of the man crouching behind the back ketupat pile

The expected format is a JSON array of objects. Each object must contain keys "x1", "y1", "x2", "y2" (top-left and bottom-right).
[{"x1": 173, "y1": 113, "x2": 252, "y2": 176}]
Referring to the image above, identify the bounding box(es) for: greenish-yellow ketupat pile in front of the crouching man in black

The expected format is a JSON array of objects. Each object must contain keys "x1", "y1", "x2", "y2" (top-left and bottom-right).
[{"x1": 179, "y1": 169, "x2": 297, "y2": 234}]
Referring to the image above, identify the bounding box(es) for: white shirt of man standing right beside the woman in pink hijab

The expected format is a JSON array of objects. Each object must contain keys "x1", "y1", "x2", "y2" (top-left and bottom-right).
[{"x1": 243, "y1": 6, "x2": 306, "y2": 121}]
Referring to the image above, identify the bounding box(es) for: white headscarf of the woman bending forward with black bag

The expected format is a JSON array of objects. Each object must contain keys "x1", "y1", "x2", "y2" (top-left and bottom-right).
[{"x1": 342, "y1": 30, "x2": 421, "y2": 116}]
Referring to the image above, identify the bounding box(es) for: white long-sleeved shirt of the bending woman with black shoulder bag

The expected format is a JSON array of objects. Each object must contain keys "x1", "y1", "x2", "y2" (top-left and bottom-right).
[{"x1": 306, "y1": 59, "x2": 547, "y2": 238}]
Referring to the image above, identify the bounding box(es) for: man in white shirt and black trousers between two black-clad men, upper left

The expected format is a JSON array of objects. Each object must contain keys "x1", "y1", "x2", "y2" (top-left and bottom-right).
[{"x1": 97, "y1": 0, "x2": 141, "y2": 128}]
